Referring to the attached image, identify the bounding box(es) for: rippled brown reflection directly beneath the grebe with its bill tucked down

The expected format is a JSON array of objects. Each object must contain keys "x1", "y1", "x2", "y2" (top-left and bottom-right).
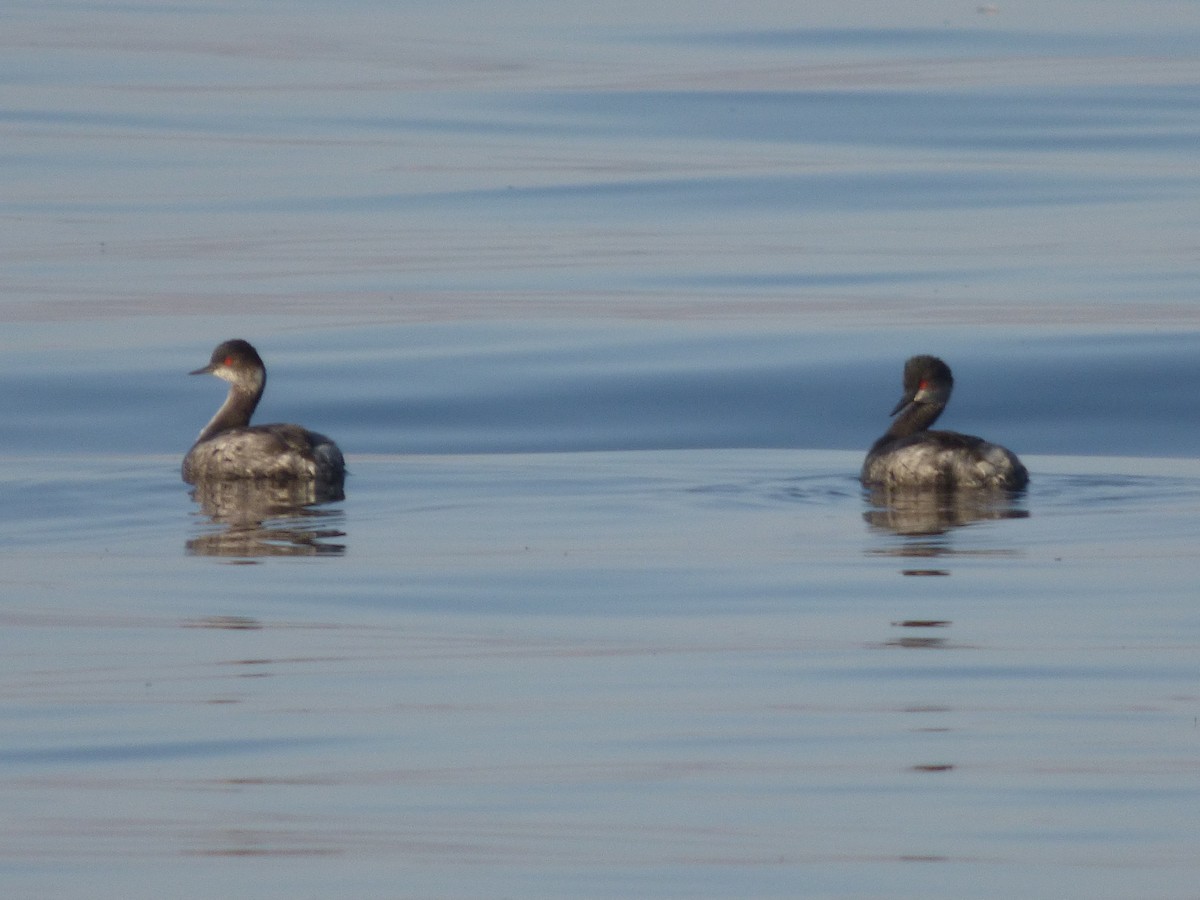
[{"x1": 863, "y1": 486, "x2": 1030, "y2": 535}]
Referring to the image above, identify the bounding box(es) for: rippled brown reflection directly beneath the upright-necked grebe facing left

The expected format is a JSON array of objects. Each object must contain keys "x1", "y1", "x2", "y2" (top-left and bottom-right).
[{"x1": 185, "y1": 479, "x2": 346, "y2": 557}]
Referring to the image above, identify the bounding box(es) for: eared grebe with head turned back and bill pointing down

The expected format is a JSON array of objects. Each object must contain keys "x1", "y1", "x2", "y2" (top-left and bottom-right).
[{"x1": 862, "y1": 356, "x2": 1030, "y2": 490}]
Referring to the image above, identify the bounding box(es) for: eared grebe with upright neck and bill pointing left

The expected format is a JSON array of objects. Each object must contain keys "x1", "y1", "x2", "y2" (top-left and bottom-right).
[{"x1": 184, "y1": 341, "x2": 346, "y2": 486}]
